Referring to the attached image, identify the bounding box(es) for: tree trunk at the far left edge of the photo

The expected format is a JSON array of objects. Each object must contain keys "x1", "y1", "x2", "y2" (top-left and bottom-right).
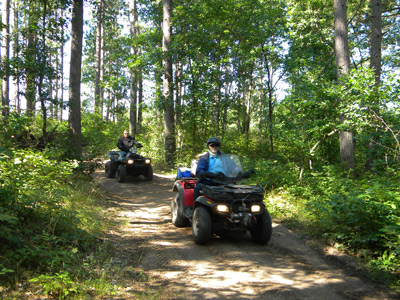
[{"x1": 1, "y1": 0, "x2": 10, "y2": 116}]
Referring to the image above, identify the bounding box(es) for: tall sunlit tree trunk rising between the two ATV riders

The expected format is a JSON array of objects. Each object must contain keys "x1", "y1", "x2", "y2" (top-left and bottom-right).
[{"x1": 162, "y1": 0, "x2": 176, "y2": 167}]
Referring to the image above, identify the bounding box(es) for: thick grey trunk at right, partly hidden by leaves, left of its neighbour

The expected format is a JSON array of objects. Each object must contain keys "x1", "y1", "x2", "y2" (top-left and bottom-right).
[{"x1": 334, "y1": 0, "x2": 355, "y2": 170}]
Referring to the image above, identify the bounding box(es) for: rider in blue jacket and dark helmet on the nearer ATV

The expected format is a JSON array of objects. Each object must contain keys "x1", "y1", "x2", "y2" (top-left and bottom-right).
[{"x1": 193, "y1": 137, "x2": 223, "y2": 200}]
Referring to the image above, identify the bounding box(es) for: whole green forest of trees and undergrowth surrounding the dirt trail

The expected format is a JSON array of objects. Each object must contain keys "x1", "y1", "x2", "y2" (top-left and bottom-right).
[{"x1": 0, "y1": 0, "x2": 400, "y2": 298}]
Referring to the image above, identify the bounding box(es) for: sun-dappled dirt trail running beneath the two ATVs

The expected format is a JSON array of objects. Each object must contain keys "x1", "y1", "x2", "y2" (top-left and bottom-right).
[{"x1": 93, "y1": 171, "x2": 395, "y2": 300}]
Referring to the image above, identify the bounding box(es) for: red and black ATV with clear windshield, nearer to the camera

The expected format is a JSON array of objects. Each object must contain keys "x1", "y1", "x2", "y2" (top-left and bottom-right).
[{"x1": 171, "y1": 154, "x2": 272, "y2": 245}]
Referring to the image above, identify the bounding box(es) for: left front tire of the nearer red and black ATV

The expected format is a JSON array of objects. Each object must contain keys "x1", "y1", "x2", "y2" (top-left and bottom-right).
[{"x1": 192, "y1": 206, "x2": 212, "y2": 245}]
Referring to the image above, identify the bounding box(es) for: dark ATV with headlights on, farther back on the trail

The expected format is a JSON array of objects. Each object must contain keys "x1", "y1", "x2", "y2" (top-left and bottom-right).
[{"x1": 105, "y1": 143, "x2": 153, "y2": 183}]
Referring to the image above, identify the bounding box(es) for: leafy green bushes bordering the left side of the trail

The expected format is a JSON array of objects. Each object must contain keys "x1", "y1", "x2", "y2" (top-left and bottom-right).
[{"x1": 0, "y1": 149, "x2": 115, "y2": 299}]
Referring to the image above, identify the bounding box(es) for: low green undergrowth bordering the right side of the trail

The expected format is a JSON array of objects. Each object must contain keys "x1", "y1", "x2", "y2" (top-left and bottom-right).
[{"x1": 266, "y1": 162, "x2": 400, "y2": 284}]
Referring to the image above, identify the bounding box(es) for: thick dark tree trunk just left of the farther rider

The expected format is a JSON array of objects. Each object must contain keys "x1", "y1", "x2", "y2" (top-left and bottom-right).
[{"x1": 68, "y1": 0, "x2": 83, "y2": 156}]
